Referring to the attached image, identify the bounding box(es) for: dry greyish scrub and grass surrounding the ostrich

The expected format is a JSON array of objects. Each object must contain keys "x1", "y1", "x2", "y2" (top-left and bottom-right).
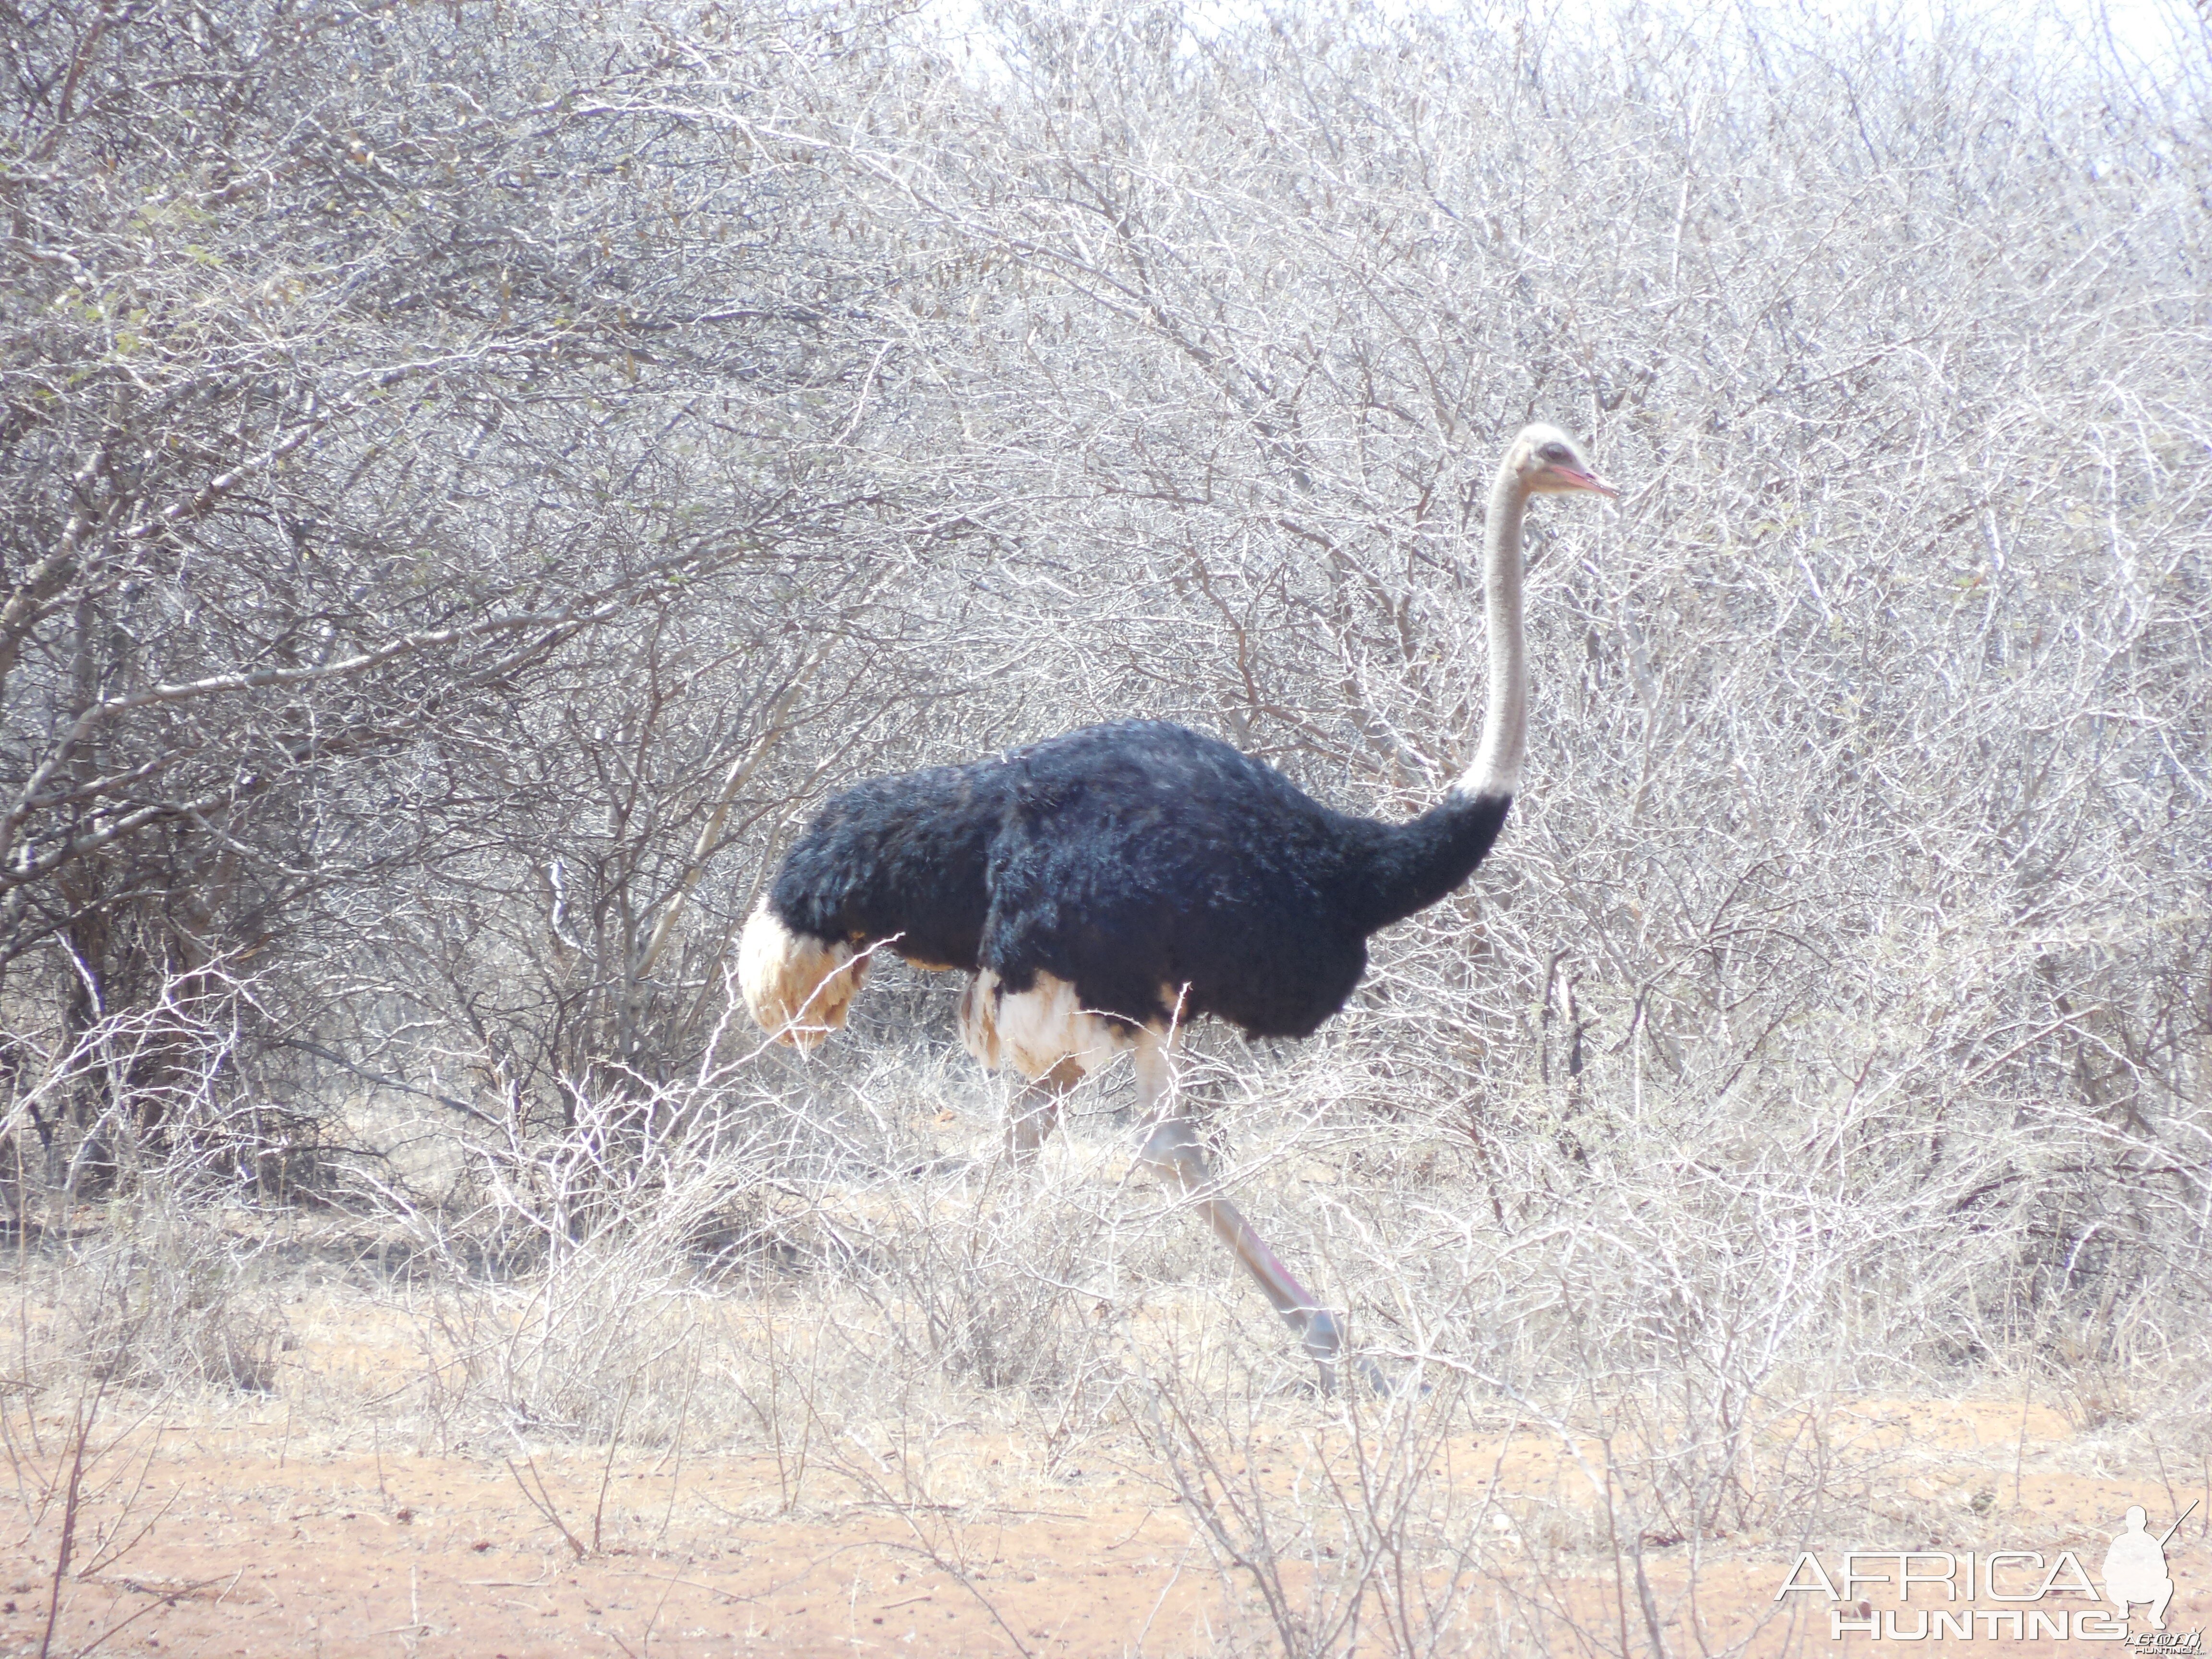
[{"x1": 0, "y1": 0, "x2": 2212, "y2": 1655}]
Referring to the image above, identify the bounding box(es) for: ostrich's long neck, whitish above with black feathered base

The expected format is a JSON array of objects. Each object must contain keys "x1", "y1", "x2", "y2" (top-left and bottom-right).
[{"x1": 1349, "y1": 451, "x2": 1528, "y2": 934}]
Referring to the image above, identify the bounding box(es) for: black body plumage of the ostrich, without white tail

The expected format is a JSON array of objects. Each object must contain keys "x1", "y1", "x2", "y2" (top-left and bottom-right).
[{"x1": 768, "y1": 721, "x2": 1511, "y2": 1037}]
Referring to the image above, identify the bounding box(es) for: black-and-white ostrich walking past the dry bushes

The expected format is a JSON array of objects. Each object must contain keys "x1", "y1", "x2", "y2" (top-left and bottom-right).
[{"x1": 739, "y1": 425, "x2": 1615, "y2": 1385}]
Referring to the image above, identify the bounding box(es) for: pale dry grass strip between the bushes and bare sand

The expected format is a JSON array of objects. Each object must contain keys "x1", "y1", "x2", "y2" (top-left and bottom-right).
[{"x1": 7, "y1": 1037, "x2": 2205, "y2": 1655}]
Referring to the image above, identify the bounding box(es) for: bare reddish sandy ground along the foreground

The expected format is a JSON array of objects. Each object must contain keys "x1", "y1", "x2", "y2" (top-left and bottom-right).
[{"x1": 0, "y1": 1400, "x2": 2212, "y2": 1659}]
